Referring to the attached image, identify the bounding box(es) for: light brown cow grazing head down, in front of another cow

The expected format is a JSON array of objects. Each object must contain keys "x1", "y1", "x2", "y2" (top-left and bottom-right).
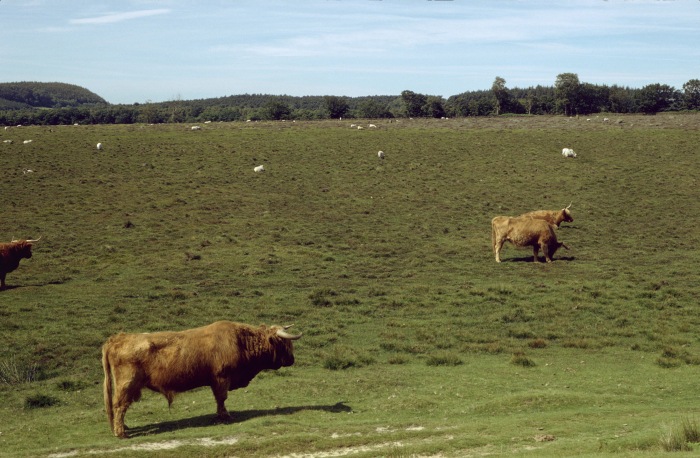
[{"x1": 491, "y1": 216, "x2": 569, "y2": 262}]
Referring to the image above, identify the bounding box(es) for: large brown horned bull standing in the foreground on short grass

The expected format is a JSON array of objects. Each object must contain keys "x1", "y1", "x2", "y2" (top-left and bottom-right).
[{"x1": 102, "y1": 321, "x2": 301, "y2": 437}]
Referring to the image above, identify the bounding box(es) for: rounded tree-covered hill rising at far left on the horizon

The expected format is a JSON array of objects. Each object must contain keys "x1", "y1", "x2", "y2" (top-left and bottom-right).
[{"x1": 0, "y1": 82, "x2": 107, "y2": 110}]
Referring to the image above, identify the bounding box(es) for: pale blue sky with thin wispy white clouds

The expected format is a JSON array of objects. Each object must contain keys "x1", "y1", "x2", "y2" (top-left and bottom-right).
[{"x1": 0, "y1": 0, "x2": 700, "y2": 104}]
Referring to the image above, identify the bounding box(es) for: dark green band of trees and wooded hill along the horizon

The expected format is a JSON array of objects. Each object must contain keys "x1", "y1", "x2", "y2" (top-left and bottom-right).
[{"x1": 0, "y1": 73, "x2": 700, "y2": 126}]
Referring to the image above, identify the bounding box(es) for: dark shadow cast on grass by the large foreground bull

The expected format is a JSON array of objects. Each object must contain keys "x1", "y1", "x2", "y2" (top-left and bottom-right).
[{"x1": 127, "y1": 401, "x2": 352, "y2": 437}]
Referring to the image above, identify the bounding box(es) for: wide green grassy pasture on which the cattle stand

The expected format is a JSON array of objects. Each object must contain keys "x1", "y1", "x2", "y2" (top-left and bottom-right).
[{"x1": 0, "y1": 114, "x2": 700, "y2": 458}]
